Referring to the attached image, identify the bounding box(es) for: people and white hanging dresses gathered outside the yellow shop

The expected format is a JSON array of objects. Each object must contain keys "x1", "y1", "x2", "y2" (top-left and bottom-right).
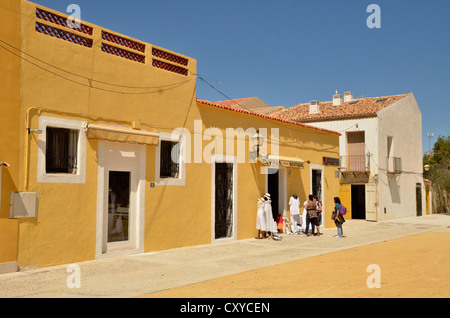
[{"x1": 256, "y1": 193, "x2": 345, "y2": 240}]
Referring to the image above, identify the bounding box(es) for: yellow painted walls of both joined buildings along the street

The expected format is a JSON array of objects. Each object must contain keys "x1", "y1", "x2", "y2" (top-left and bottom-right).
[{"x1": 0, "y1": 1, "x2": 339, "y2": 266}]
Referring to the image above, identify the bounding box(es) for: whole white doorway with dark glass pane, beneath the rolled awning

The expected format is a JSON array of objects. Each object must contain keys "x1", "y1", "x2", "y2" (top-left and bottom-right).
[{"x1": 96, "y1": 141, "x2": 145, "y2": 257}]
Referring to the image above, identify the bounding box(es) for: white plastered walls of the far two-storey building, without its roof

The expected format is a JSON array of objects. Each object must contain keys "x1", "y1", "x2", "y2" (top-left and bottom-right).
[{"x1": 308, "y1": 94, "x2": 426, "y2": 220}]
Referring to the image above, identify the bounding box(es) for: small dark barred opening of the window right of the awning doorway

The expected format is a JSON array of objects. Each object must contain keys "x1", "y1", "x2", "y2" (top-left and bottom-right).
[{"x1": 159, "y1": 140, "x2": 180, "y2": 178}]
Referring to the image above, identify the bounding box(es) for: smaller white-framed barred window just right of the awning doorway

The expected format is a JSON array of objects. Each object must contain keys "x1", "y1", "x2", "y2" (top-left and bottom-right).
[{"x1": 155, "y1": 132, "x2": 185, "y2": 186}]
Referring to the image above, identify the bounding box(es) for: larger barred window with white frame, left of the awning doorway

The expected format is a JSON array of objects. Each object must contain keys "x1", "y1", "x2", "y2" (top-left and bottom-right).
[{"x1": 37, "y1": 116, "x2": 86, "y2": 183}]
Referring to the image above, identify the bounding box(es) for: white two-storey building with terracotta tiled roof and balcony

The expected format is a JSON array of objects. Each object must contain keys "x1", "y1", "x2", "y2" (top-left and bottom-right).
[{"x1": 278, "y1": 93, "x2": 431, "y2": 221}]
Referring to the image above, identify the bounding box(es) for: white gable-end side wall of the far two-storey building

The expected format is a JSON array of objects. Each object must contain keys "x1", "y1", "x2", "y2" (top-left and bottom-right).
[{"x1": 378, "y1": 94, "x2": 426, "y2": 220}]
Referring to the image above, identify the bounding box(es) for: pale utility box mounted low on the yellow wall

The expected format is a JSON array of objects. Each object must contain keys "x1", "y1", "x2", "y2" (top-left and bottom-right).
[{"x1": 9, "y1": 192, "x2": 39, "y2": 219}]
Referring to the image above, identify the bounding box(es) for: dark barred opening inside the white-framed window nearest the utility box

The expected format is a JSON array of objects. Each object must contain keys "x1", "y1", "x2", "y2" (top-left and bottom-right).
[{"x1": 45, "y1": 127, "x2": 78, "y2": 174}]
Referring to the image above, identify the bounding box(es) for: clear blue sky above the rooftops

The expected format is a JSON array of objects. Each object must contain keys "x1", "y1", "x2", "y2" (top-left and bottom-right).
[{"x1": 32, "y1": 0, "x2": 450, "y2": 152}]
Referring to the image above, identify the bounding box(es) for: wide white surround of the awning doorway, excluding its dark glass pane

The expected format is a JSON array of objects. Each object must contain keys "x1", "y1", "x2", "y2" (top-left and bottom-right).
[{"x1": 95, "y1": 140, "x2": 146, "y2": 259}]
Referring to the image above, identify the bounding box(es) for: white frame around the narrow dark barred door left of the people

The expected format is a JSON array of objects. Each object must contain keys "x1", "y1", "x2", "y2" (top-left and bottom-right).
[{"x1": 211, "y1": 155, "x2": 238, "y2": 243}]
